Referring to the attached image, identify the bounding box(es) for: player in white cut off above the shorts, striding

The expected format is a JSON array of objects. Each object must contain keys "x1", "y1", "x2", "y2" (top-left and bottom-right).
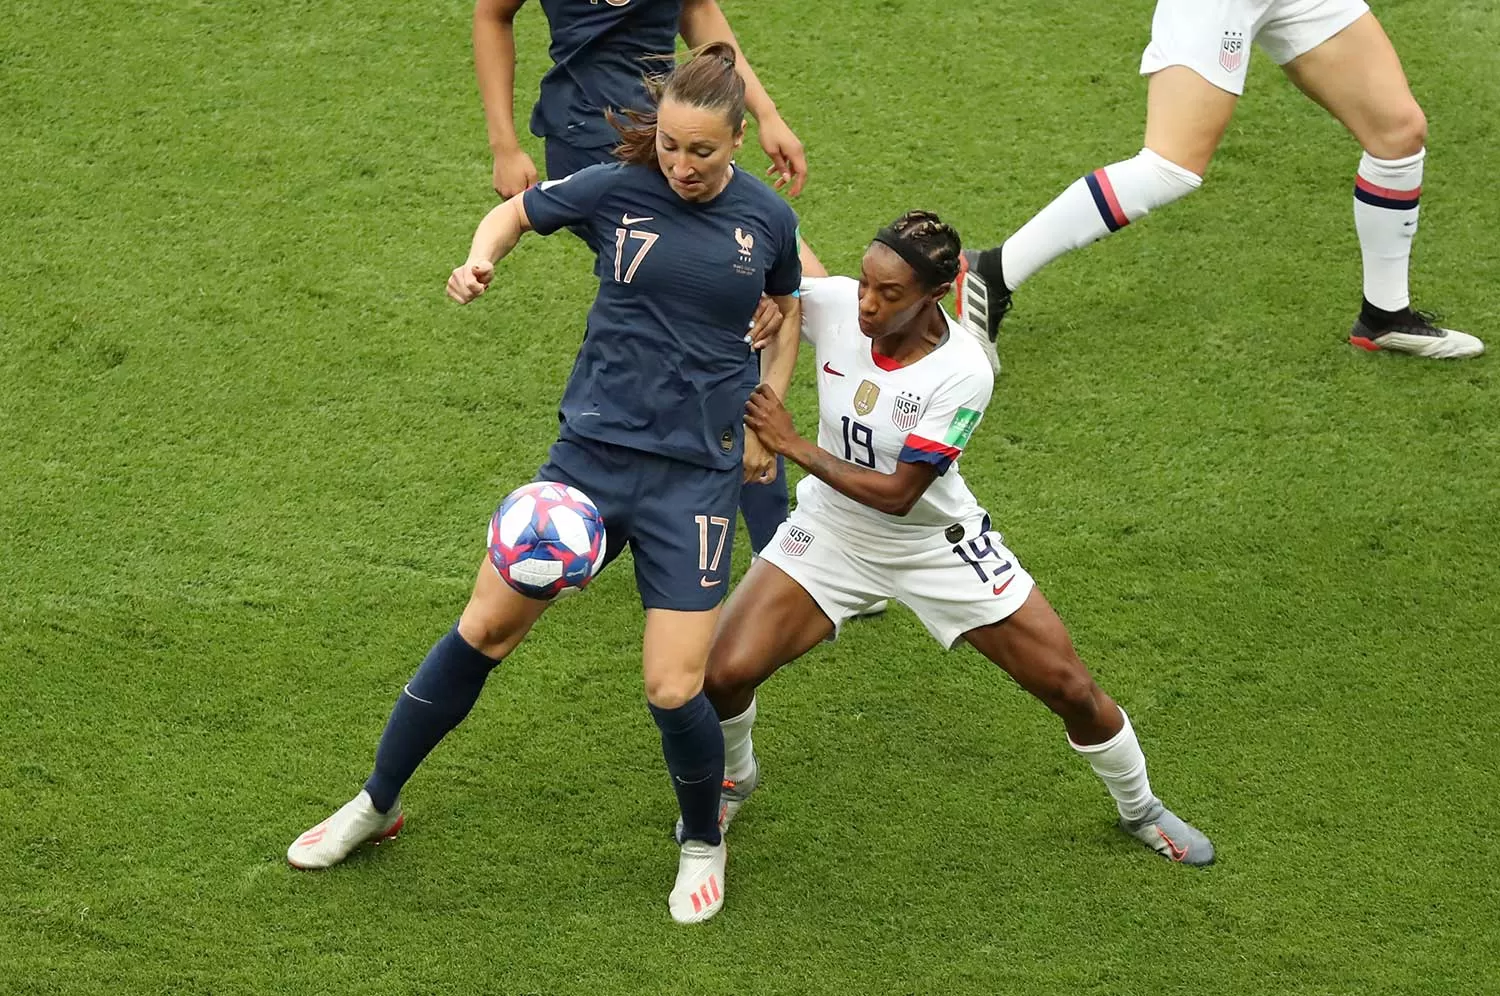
[{"x1": 959, "y1": 0, "x2": 1485, "y2": 359}]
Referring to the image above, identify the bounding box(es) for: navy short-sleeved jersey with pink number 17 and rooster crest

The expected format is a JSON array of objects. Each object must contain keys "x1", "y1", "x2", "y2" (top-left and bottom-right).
[{"x1": 524, "y1": 164, "x2": 803, "y2": 470}]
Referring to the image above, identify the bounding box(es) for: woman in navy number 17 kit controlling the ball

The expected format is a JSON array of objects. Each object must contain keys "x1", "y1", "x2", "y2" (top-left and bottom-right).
[{"x1": 287, "y1": 45, "x2": 801, "y2": 923}]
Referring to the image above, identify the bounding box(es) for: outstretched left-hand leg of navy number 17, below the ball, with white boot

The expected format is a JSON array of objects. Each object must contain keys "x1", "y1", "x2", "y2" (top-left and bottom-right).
[{"x1": 287, "y1": 558, "x2": 549, "y2": 869}]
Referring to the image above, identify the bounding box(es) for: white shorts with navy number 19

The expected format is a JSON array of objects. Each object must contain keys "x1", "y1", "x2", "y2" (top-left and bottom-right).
[{"x1": 761, "y1": 507, "x2": 1037, "y2": 648}]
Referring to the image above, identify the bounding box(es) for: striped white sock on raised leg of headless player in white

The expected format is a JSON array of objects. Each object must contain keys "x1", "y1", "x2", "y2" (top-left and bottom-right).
[{"x1": 1001, "y1": 149, "x2": 1203, "y2": 291}]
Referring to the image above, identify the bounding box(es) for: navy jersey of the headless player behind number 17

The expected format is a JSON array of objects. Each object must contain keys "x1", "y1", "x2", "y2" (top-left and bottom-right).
[{"x1": 531, "y1": 0, "x2": 683, "y2": 149}]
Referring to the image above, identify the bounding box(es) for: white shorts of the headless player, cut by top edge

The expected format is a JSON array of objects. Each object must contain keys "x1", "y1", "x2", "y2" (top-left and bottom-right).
[{"x1": 1140, "y1": 0, "x2": 1370, "y2": 96}]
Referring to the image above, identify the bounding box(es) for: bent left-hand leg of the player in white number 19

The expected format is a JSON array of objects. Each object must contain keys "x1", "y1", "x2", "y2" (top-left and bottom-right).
[{"x1": 704, "y1": 560, "x2": 834, "y2": 792}]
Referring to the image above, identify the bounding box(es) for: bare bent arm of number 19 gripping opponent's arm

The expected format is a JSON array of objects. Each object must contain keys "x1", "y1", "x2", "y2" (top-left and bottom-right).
[{"x1": 746, "y1": 384, "x2": 941, "y2": 516}]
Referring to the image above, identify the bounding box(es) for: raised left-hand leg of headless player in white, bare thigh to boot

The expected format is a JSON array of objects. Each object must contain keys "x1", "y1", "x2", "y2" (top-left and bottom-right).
[{"x1": 959, "y1": 66, "x2": 1238, "y2": 339}]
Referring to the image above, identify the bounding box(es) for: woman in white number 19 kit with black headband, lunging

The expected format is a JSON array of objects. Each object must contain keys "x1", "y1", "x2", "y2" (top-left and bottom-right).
[{"x1": 687, "y1": 212, "x2": 1214, "y2": 912}]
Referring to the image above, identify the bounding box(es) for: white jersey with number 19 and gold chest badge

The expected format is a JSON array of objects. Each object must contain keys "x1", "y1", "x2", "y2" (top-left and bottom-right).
[{"x1": 797, "y1": 276, "x2": 995, "y2": 536}]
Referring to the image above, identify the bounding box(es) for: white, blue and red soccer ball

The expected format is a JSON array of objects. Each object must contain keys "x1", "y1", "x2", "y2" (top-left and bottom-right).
[{"x1": 489, "y1": 480, "x2": 605, "y2": 599}]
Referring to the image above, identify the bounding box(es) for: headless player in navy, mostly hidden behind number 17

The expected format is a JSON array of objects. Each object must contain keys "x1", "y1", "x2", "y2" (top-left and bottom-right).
[{"x1": 474, "y1": 0, "x2": 807, "y2": 549}]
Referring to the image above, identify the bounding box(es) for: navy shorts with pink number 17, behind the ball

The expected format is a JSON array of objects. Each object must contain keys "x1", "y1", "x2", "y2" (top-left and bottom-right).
[{"x1": 537, "y1": 434, "x2": 744, "y2": 612}]
